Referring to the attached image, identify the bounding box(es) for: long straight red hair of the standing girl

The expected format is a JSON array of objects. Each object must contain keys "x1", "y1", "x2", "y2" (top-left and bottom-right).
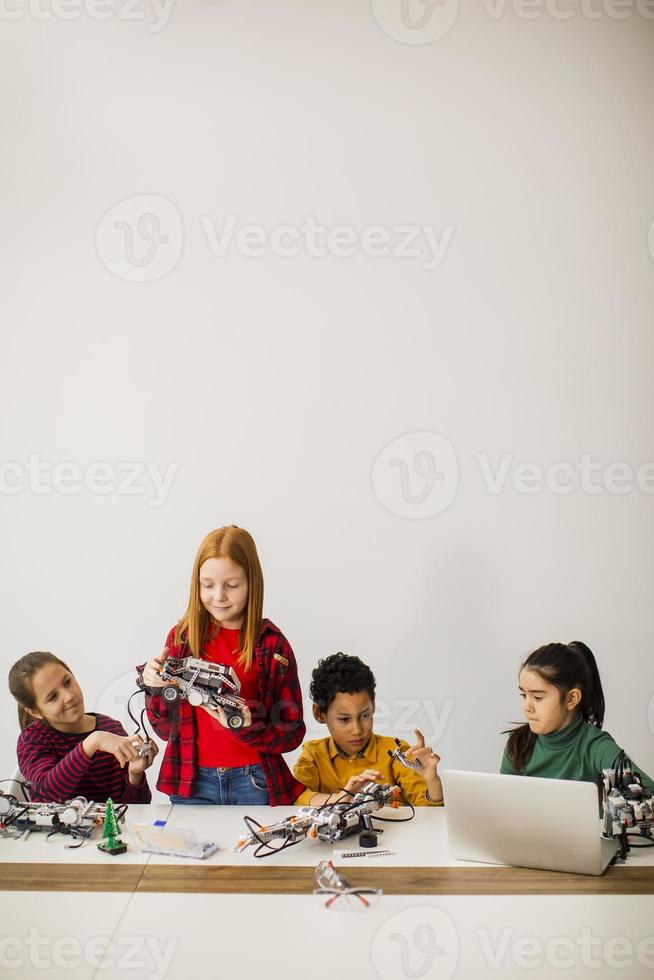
[{"x1": 175, "y1": 524, "x2": 263, "y2": 670}]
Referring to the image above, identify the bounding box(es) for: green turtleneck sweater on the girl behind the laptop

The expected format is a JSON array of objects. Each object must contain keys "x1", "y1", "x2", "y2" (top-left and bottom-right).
[{"x1": 500, "y1": 715, "x2": 654, "y2": 793}]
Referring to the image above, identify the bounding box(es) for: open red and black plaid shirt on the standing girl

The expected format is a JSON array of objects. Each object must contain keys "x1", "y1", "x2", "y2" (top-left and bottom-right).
[{"x1": 136, "y1": 619, "x2": 306, "y2": 806}]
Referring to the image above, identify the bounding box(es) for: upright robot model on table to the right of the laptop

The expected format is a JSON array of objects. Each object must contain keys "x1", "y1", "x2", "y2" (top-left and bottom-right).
[{"x1": 601, "y1": 752, "x2": 654, "y2": 860}]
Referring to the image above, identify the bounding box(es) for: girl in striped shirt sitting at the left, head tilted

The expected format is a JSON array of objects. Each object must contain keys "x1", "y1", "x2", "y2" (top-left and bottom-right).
[{"x1": 9, "y1": 652, "x2": 158, "y2": 803}]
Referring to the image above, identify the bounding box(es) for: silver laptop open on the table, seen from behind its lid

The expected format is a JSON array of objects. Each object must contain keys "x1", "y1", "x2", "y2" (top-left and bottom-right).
[{"x1": 440, "y1": 769, "x2": 618, "y2": 875}]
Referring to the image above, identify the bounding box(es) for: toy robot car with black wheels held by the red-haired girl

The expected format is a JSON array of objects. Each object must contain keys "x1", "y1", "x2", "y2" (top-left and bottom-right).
[{"x1": 138, "y1": 657, "x2": 246, "y2": 729}]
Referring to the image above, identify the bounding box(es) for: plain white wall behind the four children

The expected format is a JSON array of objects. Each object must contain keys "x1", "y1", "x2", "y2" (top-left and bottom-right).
[{"x1": 0, "y1": 0, "x2": 654, "y2": 804}]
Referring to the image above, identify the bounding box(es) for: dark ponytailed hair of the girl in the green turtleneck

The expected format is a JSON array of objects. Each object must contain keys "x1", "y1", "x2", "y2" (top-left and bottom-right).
[{"x1": 503, "y1": 640, "x2": 605, "y2": 773}]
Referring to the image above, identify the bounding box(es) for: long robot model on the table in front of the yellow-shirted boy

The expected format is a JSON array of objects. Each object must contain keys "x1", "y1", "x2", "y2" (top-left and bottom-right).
[{"x1": 236, "y1": 782, "x2": 401, "y2": 857}]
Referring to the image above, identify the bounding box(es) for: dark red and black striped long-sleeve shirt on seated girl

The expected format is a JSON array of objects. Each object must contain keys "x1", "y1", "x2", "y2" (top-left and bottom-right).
[{"x1": 16, "y1": 712, "x2": 152, "y2": 803}]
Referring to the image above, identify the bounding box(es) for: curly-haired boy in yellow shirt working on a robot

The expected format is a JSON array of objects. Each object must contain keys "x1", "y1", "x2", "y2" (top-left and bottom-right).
[{"x1": 293, "y1": 653, "x2": 443, "y2": 806}]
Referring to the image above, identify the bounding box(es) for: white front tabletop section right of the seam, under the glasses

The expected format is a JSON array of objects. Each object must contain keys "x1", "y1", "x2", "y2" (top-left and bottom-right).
[{"x1": 34, "y1": 893, "x2": 654, "y2": 980}]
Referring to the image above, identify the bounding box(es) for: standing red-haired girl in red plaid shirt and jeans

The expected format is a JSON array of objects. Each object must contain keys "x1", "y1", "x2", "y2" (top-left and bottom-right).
[{"x1": 137, "y1": 525, "x2": 305, "y2": 806}]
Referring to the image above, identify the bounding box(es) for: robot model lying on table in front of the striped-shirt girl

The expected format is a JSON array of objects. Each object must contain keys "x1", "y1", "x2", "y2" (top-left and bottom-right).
[{"x1": 0, "y1": 792, "x2": 127, "y2": 846}]
